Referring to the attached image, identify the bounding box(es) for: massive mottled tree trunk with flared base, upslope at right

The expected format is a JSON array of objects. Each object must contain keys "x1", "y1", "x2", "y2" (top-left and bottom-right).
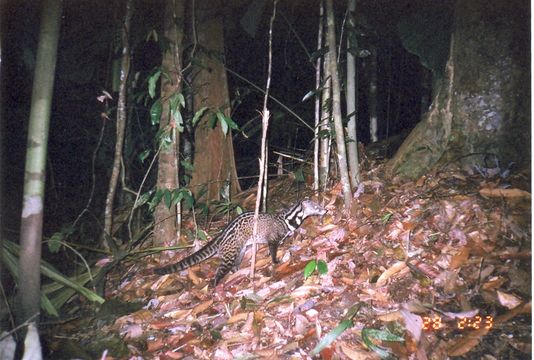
[{"x1": 389, "y1": 0, "x2": 530, "y2": 178}]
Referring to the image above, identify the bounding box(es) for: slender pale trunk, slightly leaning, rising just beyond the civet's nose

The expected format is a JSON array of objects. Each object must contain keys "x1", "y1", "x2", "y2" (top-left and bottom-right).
[{"x1": 326, "y1": 0, "x2": 352, "y2": 212}]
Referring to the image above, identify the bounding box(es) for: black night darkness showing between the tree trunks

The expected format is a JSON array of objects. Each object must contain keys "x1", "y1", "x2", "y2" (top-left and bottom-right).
[{"x1": 2, "y1": 0, "x2": 451, "y2": 241}]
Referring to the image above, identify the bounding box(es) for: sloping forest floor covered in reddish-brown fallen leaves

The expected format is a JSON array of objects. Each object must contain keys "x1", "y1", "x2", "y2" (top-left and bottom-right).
[{"x1": 44, "y1": 156, "x2": 532, "y2": 360}]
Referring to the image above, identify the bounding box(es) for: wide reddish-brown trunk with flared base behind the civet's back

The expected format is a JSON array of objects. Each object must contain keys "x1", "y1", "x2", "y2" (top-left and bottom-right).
[{"x1": 187, "y1": 0, "x2": 240, "y2": 200}]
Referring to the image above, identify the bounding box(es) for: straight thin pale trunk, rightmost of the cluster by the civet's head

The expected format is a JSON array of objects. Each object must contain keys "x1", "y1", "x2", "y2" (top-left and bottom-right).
[{"x1": 345, "y1": 0, "x2": 360, "y2": 187}]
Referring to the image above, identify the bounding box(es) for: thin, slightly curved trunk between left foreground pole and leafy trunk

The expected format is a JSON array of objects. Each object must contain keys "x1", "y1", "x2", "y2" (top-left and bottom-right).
[{"x1": 102, "y1": 0, "x2": 133, "y2": 249}]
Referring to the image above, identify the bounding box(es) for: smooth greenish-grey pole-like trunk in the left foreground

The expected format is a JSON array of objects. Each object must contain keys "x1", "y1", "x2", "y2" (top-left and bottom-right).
[{"x1": 18, "y1": 0, "x2": 62, "y2": 322}]
